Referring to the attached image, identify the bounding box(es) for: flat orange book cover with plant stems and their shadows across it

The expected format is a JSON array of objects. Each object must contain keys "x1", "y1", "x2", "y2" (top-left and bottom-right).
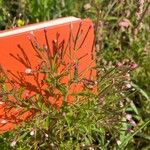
[{"x1": 0, "y1": 19, "x2": 96, "y2": 133}]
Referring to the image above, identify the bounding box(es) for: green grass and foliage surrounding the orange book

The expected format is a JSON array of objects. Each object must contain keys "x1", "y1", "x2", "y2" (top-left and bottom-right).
[{"x1": 0, "y1": 0, "x2": 150, "y2": 150}]
